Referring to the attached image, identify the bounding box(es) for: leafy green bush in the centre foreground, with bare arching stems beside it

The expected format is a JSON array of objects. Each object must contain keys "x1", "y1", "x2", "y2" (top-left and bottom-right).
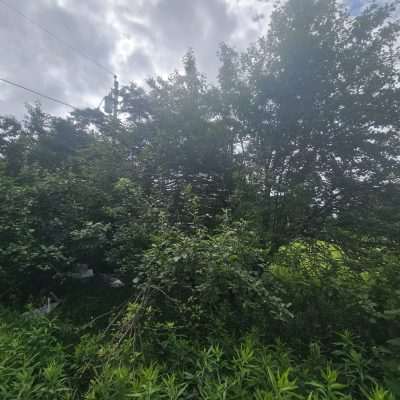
[{"x1": 130, "y1": 223, "x2": 292, "y2": 337}]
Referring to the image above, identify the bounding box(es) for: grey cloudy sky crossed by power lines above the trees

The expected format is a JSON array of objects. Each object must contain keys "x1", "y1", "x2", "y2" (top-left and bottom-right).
[{"x1": 0, "y1": 0, "x2": 363, "y2": 117}]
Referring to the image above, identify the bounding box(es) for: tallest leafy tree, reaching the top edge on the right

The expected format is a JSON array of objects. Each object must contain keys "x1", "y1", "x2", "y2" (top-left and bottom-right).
[{"x1": 220, "y1": 0, "x2": 400, "y2": 248}]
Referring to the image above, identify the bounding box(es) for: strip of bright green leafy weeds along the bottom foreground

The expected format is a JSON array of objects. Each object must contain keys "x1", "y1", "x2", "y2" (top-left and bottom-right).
[{"x1": 0, "y1": 304, "x2": 399, "y2": 400}]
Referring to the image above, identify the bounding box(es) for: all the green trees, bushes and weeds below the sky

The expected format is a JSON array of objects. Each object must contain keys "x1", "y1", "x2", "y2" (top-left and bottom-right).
[{"x1": 0, "y1": 0, "x2": 400, "y2": 400}]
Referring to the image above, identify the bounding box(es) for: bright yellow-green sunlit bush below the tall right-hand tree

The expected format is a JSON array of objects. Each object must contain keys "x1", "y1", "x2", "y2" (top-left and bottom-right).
[{"x1": 269, "y1": 241, "x2": 382, "y2": 343}]
